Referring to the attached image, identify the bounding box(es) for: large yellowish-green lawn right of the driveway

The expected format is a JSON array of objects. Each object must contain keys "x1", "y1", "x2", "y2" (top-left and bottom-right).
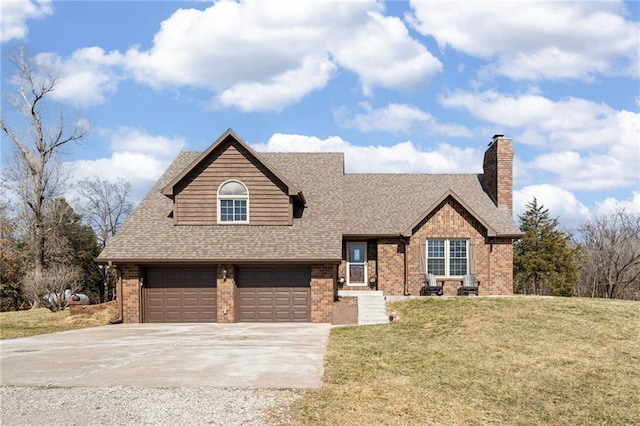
[{"x1": 294, "y1": 298, "x2": 640, "y2": 425}]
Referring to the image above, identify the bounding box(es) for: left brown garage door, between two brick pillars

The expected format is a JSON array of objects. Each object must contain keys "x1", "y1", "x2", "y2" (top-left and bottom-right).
[{"x1": 143, "y1": 268, "x2": 217, "y2": 322}]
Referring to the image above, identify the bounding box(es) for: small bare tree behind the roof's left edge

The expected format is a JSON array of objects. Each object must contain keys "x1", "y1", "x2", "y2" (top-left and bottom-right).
[{"x1": 77, "y1": 177, "x2": 133, "y2": 302}]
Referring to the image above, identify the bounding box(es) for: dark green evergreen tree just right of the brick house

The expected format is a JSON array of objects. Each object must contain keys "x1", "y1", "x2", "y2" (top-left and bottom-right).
[{"x1": 513, "y1": 198, "x2": 577, "y2": 296}]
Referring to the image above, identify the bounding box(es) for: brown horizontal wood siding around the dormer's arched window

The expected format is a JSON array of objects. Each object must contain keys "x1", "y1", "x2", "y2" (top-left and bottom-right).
[{"x1": 174, "y1": 140, "x2": 293, "y2": 225}]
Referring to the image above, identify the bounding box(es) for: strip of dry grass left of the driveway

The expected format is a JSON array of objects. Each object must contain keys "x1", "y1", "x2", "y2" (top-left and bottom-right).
[{"x1": 0, "y1": 308, "x2": 117, "y2": 339}]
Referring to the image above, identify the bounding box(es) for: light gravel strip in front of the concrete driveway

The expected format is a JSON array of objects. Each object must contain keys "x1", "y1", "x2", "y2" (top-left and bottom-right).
[{"x1": 0, "y1": 386, "x2": 304, "y2": 426}]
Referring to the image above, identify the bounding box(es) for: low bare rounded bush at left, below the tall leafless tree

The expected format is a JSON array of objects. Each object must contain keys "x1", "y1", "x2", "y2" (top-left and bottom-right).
[{"x1": 23, "y1": 264, "x2": 80, "y2": 312}]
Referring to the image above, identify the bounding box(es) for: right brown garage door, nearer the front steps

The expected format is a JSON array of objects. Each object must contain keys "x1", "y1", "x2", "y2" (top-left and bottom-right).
[{"x1": 238, "y1": 268, "x2": 311, "y2": 322}]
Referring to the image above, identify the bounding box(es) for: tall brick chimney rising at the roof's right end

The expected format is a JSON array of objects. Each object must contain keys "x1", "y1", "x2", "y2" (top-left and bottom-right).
[{"x1": 482, "y1": 135, "x2": 513, "y2": 215}]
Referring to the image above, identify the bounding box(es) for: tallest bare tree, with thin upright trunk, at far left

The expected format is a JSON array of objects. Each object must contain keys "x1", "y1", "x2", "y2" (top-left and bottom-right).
[{"x1": 0, "y1": 49, "x2": 87, "y2": 271}]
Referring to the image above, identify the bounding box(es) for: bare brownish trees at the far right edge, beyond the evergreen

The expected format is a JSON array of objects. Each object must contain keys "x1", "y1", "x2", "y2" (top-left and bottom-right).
[{"x1": 578, "y1": 209, "x2": 640, "y2": 299}]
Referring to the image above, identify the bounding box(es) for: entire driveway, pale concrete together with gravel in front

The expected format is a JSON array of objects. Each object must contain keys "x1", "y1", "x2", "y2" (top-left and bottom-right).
[{"x1": 0, "y1": 324, "x2": 330, "y2": 426}]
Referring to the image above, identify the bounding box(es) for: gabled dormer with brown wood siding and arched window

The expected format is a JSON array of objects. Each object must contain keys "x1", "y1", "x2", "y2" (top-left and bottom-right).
[{"x1": 162, "y1": 129, "x2": 305, "y2": 226}]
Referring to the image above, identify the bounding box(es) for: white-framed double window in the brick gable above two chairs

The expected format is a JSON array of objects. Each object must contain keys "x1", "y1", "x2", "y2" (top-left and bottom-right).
[{"x1": 426, "y1": 239, "x2": 469, "y2": 277}]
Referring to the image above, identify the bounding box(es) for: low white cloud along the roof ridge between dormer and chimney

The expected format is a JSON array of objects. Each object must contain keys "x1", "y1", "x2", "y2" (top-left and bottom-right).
[{"x1": 253, "y1": 133, "x2": 482, "y2": 173}]
